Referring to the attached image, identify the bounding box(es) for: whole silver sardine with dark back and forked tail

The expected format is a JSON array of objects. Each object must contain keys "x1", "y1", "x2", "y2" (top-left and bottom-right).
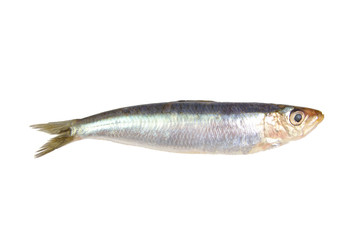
[{"x1": 31, "y1": 101, "x2": 324, "y2": 157}]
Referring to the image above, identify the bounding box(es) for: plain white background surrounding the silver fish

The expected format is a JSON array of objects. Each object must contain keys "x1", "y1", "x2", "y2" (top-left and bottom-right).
[{"x1": 0, "y1": 0, "x2": 360, "y2": 240}]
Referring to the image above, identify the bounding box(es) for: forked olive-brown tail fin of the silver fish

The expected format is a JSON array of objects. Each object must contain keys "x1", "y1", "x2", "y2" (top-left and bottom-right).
[{"x1": 30, "y1": 120, "x2": 77, "y2": 158}]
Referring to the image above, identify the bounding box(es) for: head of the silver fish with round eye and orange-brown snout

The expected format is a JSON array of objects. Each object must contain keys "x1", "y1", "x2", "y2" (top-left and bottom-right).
[{"x1": 265, "y1": 106, "x2": 324, "y2": 146}]
